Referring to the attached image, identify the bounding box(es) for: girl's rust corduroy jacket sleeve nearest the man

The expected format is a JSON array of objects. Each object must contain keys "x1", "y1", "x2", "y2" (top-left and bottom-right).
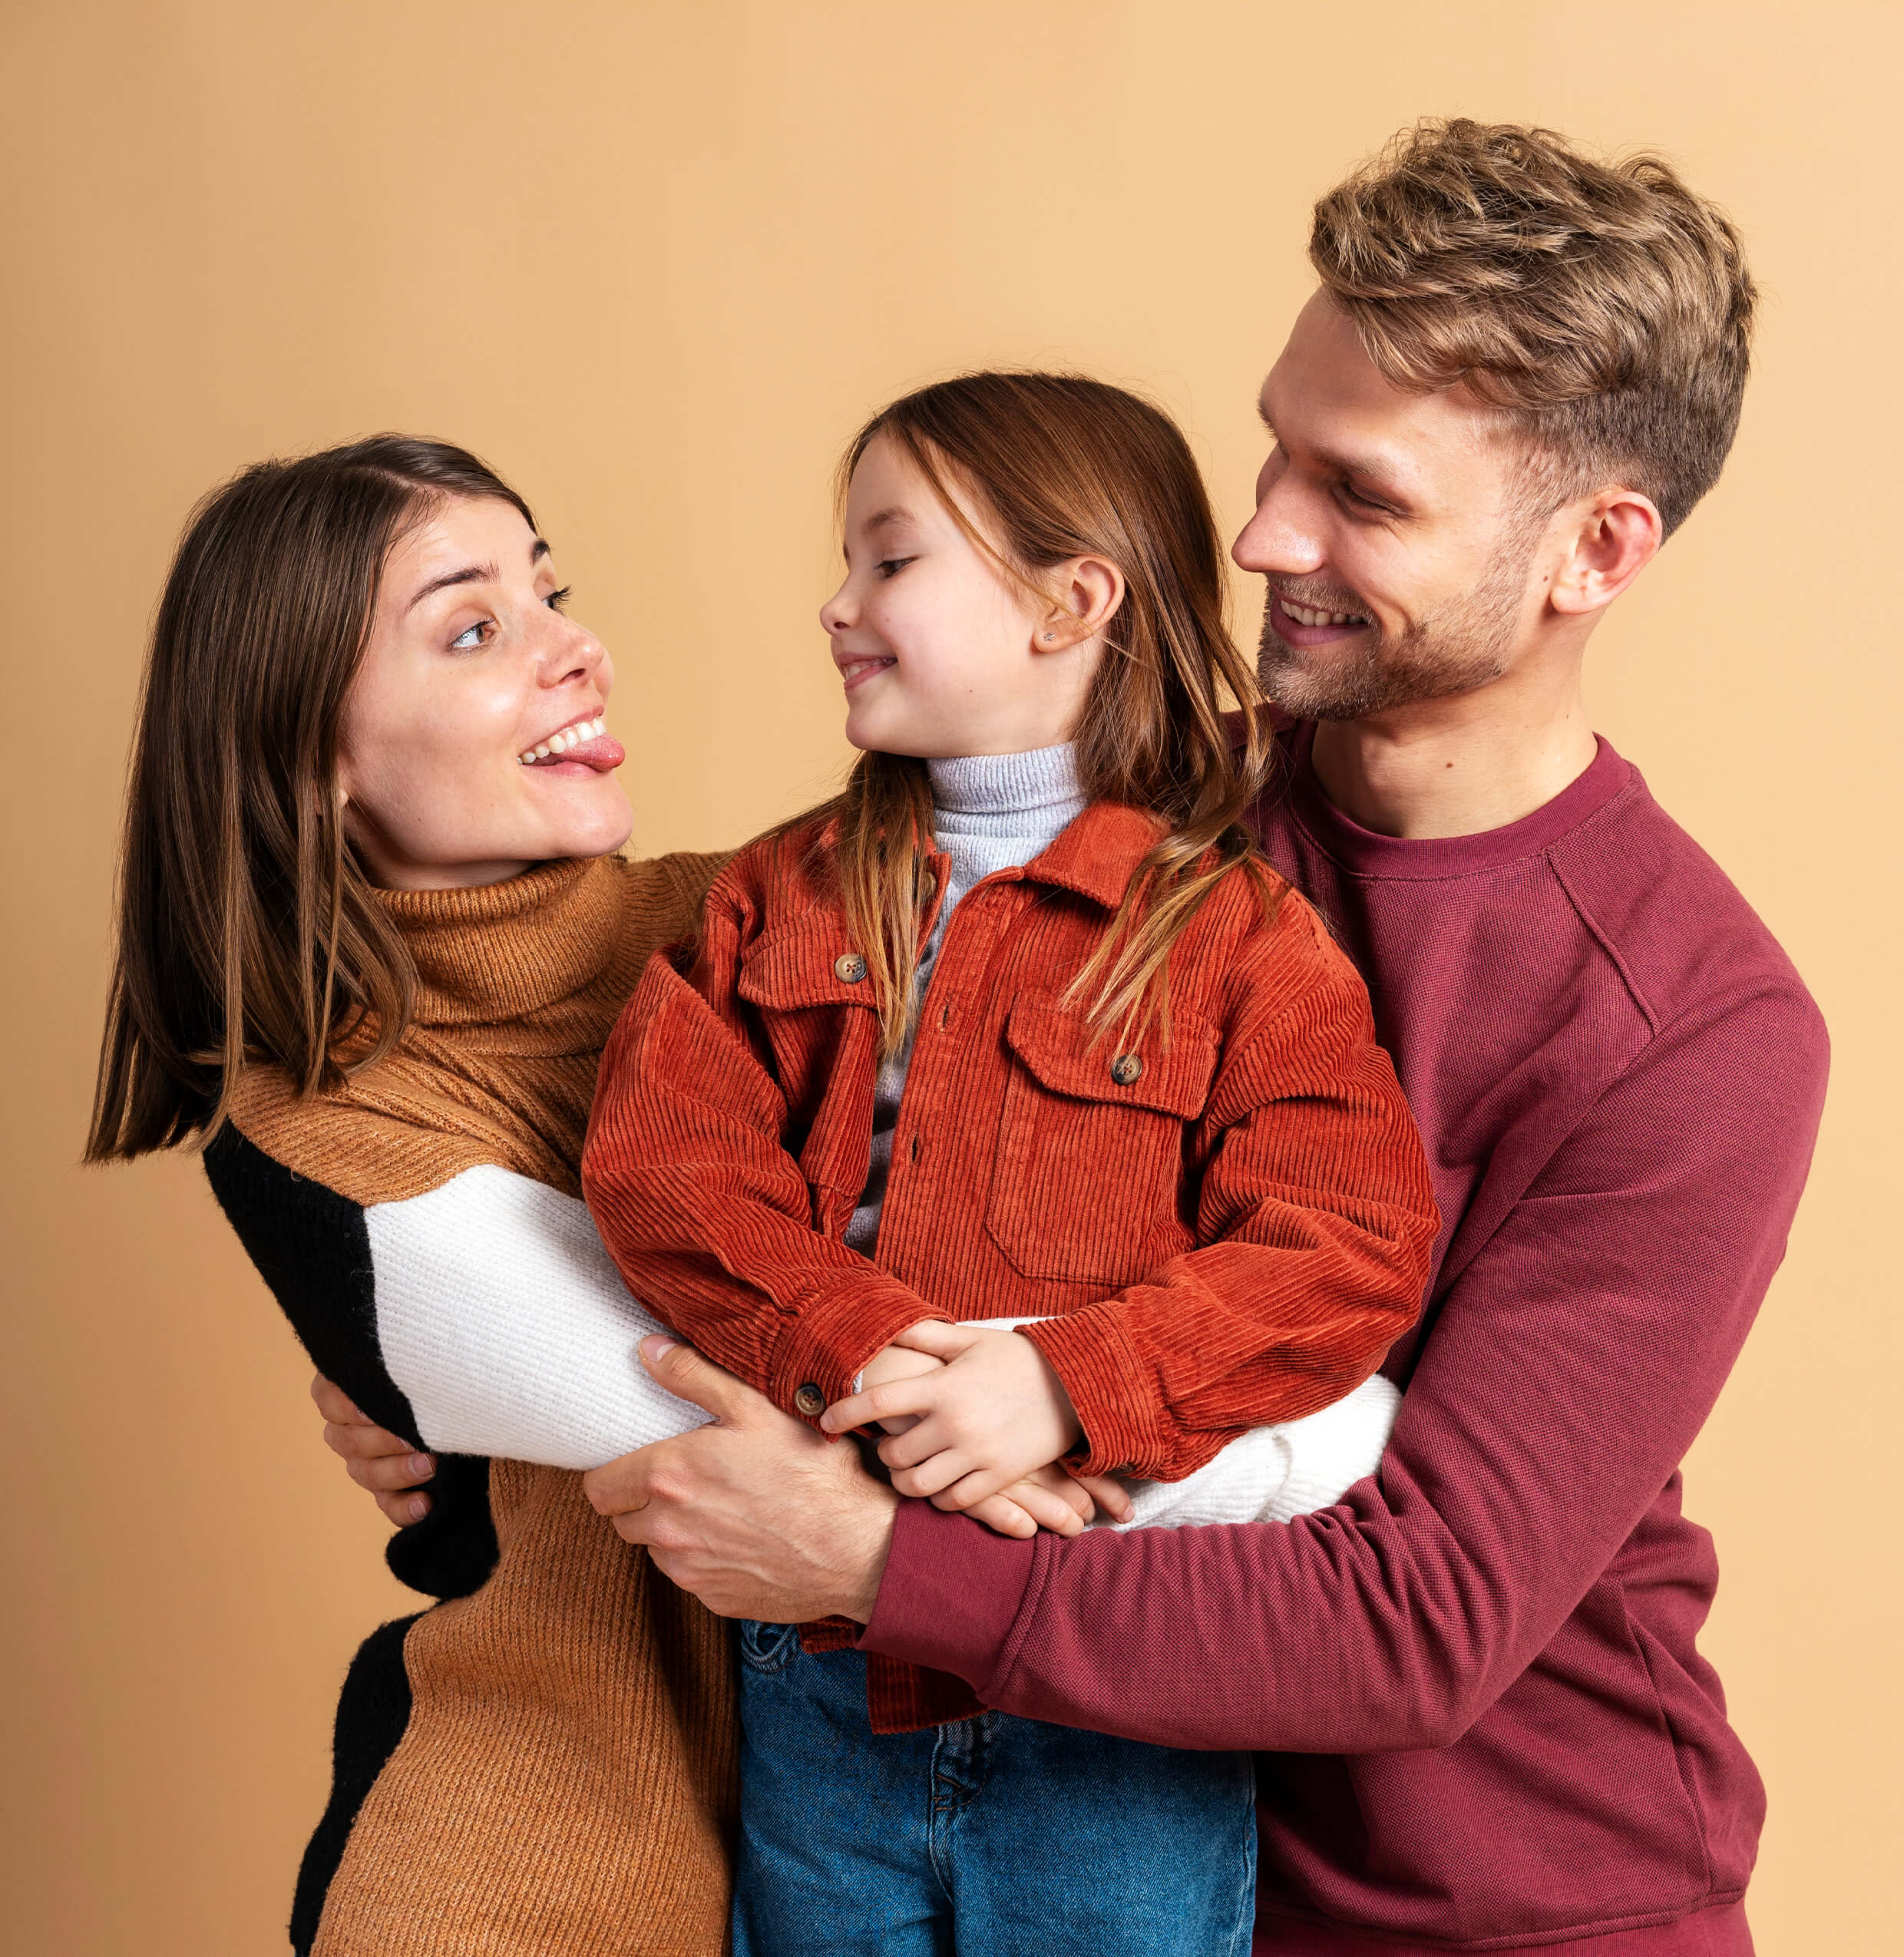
[{"x1": 1021, "y1": 901, "x2": 1438, "y2": 1482}]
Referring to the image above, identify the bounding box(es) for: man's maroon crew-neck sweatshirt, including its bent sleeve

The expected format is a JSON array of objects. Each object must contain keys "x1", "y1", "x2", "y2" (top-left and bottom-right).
[{"x1": 861, "y1": 728, "x2": 1826, "y2": 1957}]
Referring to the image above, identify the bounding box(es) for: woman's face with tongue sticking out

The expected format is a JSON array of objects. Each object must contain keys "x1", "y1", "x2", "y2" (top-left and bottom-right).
[{"x1": 339, "y1": 497, "x2": 634, "y2": 891}]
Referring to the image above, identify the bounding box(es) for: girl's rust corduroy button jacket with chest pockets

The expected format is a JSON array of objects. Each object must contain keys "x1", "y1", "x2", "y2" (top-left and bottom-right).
[{"x1": 581, "y1": 802, "x2": 1436, "y2": 1479}]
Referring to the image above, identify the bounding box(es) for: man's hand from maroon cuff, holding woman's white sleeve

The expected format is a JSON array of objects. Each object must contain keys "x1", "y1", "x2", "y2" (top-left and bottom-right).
[{"x1": 581, "y1": 1334, "x2": 898, "y2": 1625}]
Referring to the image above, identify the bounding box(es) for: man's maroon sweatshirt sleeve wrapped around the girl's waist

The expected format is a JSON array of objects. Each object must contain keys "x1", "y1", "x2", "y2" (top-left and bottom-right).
[{"x1": 861, "y1": 970, "x2": 1826, "y2": 1754}]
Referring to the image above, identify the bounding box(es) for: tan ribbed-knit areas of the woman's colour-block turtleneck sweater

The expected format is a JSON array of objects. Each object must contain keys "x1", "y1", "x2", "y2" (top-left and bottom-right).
[{"x1": 236, "y1": 857, "x2": 735, "y2": 1957}]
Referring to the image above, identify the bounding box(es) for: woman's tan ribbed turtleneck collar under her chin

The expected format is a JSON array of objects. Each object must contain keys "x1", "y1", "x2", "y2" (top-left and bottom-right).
[{"x1": 375, "y1": 857, "x2": 626, "y2": 1026}]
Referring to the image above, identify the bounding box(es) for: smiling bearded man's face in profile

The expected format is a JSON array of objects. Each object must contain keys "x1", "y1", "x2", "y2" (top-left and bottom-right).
[{"x1": 1231, "y1": 293, "x2": 1550, "y2": 720}]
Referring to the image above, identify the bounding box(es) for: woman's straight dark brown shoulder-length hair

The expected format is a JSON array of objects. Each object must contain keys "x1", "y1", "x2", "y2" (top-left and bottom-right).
[{"x1": 86, "y1": 435, "x2": 534, "y2": 1162}]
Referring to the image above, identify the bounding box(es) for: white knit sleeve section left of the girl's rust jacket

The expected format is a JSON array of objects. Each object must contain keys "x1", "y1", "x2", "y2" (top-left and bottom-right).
[{"x1": 364, "y1": 1165, "x2": 709, "y2": 1468}]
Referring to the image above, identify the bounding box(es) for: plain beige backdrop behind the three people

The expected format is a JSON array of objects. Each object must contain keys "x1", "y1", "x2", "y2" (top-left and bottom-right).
[{"x1": 0, "y1": 0, "x2": 1904, "y2": 1957}]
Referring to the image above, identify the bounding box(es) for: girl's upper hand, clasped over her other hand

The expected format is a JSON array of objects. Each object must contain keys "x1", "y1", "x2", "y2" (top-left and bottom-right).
[{"x1": 820, "y1": 1319, "x2": 1082, "y2": 1511}]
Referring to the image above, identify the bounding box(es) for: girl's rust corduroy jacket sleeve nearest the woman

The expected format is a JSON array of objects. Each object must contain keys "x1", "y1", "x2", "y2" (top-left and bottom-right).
[{"x1": 581, "y1": 884, "x2": 945, "y2": 1419}]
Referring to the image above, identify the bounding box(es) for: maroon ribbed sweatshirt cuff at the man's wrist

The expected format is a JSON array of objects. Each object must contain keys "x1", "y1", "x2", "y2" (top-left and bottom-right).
[{"x1": 857, "y1": 1501, "x2": 1037, "y2": 1693}]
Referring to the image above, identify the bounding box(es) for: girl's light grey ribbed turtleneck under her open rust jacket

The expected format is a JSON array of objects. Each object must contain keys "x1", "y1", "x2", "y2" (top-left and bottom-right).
[{"x1": 845, "y1": 744, "x2": 1084, "y2": 1255}]
